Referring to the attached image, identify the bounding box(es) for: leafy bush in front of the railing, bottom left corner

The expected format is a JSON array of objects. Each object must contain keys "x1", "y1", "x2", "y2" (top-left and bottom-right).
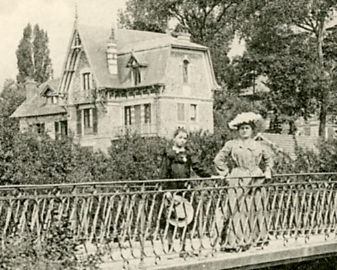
[{"x1": 0, "y1": 213, "x2": 101, "y2": 270}]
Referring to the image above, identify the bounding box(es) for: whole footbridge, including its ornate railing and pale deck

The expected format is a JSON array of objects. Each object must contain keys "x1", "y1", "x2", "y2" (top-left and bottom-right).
[{"x1": 0, "y1": 173, "x2": 337, "y2": 270}]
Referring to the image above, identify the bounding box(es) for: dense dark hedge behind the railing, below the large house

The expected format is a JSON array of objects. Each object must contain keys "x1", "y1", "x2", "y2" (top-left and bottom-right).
[{"x1": 0, "y1": 76, "x2": 337, "y2": 184}]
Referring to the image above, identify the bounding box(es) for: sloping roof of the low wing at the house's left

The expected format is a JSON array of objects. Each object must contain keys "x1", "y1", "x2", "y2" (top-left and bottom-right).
[{"x1": 11, "y1": 79, "x2": 66, "y2": 117}]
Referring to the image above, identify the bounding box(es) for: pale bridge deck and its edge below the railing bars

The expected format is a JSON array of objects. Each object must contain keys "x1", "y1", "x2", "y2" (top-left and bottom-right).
[{"x1": 89, "y1": 235, "x2": 337, "y2": 270}]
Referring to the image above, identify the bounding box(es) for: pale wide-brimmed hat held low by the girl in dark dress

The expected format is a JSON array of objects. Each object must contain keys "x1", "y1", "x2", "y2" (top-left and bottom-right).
[{"x1": 168, "y1": 195, "x2": 194, "y2": 227}]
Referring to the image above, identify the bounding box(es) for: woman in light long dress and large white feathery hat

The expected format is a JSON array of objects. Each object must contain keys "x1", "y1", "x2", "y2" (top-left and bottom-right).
[{"x1": 214, "y1": 112, "x2": 272, "y2": 251}]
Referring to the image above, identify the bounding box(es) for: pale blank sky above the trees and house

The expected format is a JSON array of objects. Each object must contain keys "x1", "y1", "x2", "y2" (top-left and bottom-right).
[{"x1": 0, "y1": 0, "x2": 244, "y2": 90}]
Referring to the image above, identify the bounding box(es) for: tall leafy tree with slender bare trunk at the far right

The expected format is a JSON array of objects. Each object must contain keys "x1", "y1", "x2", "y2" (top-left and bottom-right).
[{"x1": 236, "y1": 0, "x2": 337, "y2": 136}]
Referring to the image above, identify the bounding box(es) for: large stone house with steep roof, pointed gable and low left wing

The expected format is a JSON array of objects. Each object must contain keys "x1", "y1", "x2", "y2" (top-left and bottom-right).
[{"x1": 12, "y1": 22, "x2": 219, "y2": 150}]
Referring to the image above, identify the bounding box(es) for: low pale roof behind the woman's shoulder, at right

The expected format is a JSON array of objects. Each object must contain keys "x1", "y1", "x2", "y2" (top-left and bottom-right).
[{"x1": 255, "y1": 133, "x2": 319, "y2": 160}]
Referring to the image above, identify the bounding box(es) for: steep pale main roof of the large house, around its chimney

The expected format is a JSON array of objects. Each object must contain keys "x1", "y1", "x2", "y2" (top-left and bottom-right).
[{"x1": 75, "y1": 24, "x2": 207, "y2": 89}]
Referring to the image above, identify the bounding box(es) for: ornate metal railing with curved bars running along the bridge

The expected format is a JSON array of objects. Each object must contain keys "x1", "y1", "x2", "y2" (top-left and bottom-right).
[{"x1": 0, "y1": 172, "x2": 337, "y2": 269}]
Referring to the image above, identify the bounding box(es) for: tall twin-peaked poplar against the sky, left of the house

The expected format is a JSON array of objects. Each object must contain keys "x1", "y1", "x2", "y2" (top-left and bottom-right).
[{"x1": 16, "y1": 24, "x2": 52, "y2": 83}]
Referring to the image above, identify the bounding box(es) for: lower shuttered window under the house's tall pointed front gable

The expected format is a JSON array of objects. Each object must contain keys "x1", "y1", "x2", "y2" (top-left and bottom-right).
[{"x1": 76, "y1": 108, "x2": 98, "y2": 135}]
